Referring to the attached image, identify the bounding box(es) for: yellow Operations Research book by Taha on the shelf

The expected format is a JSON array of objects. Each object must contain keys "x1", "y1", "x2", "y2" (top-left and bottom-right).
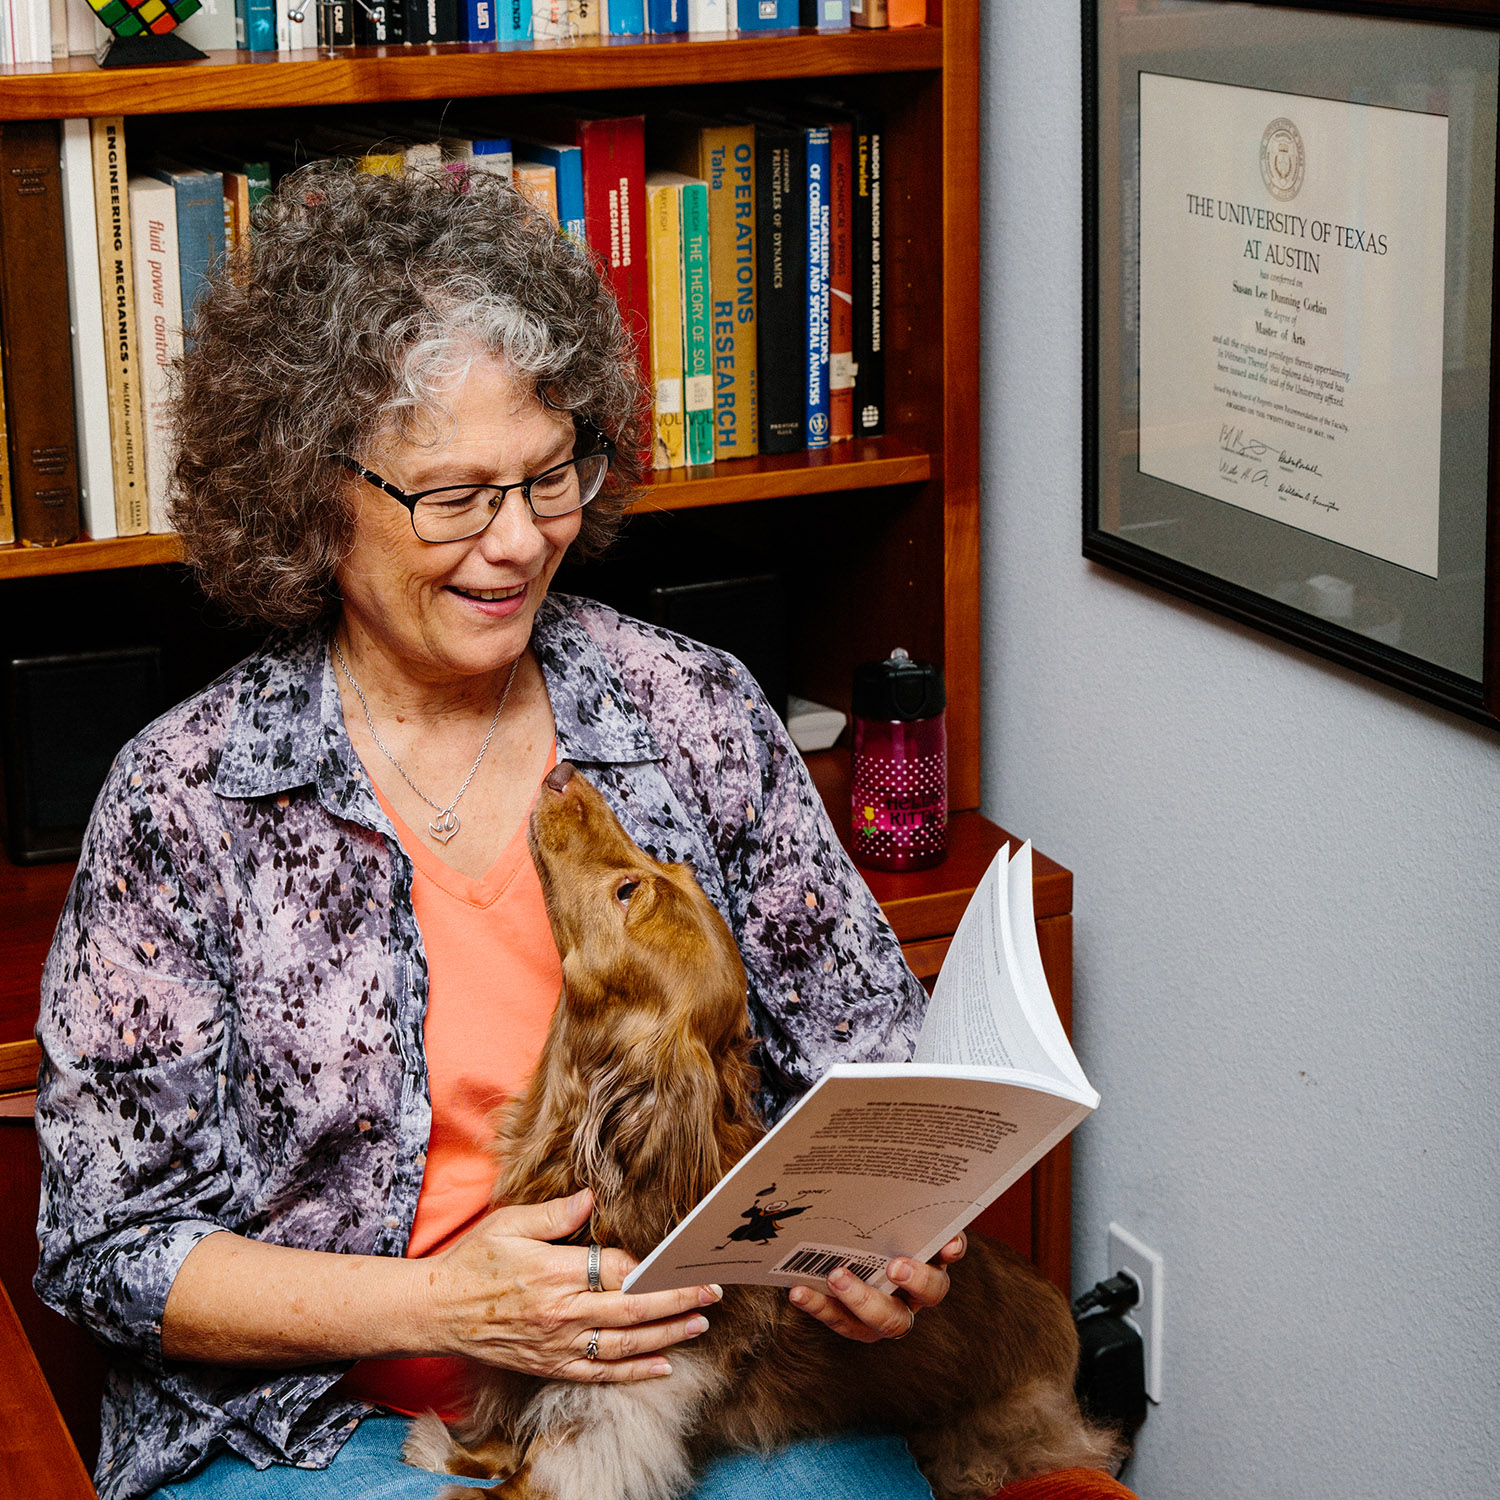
[{"x1": 651, "y1": 116, "x2": 761, "y2": 459}]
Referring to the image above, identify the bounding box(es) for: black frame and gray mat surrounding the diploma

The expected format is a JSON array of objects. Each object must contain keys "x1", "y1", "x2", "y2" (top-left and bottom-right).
[{"x1": 1082, "y1": 0, "x2": 1500, "y2": 729}]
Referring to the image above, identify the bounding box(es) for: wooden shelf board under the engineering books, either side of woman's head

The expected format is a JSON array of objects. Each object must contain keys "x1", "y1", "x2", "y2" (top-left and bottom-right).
[{"x1": 0, "y1": 438, "x2": 933, "y2": 582}]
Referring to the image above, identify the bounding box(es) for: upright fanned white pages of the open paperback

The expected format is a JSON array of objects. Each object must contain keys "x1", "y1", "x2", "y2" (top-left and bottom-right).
[{"x1": 915, "y1": 845, "x2": 1083, "y2": 1083}]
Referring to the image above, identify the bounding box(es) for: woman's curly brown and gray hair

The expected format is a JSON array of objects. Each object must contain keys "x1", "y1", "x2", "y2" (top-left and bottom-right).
[{"x1": 171, "y1": 162, "x2": 650, "y2": 627}]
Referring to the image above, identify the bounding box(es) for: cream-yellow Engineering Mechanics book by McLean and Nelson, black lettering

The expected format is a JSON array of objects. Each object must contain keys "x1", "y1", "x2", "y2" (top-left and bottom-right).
[{"x1": 90, "y1": 116, "x2": 149, "y2": 537}]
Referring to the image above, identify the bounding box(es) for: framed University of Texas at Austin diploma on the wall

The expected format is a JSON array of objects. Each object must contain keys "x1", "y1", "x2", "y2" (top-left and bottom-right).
[{"x1": 1083, "y1": 0, "x2": 1500, "y2": 728}]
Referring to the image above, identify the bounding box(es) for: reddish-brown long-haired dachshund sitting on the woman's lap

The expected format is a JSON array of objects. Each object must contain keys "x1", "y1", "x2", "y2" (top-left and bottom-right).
[{"x1": 405, "y1": 762, "x2": 1116, "y2": 1500}]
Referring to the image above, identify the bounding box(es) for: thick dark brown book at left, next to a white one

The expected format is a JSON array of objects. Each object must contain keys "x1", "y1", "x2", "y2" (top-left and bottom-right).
[{"x1": 0, "y1": 120, "x2": 80, "y2": 546}]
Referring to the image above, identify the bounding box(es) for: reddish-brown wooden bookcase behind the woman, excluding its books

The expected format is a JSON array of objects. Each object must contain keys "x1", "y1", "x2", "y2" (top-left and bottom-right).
[{"x1": 0, "y1": 0, "x2": 1073, "y2": 1494}]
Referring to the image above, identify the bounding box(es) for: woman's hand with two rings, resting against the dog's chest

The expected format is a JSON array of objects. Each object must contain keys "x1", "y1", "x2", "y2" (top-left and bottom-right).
[{"x1": 426, "y1": 1191, "x2": 723, "y2": 1382}]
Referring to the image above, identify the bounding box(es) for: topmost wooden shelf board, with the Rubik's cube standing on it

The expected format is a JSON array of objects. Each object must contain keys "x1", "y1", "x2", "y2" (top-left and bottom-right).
[{"x1": 0, "y1": 26, "x2": 944, "y2": 120}]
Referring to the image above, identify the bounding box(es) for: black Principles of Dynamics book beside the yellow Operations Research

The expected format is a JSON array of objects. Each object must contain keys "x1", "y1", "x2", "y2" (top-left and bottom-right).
[{"x1": 755, "y1": 125, "x2": 807, "y2": 453}]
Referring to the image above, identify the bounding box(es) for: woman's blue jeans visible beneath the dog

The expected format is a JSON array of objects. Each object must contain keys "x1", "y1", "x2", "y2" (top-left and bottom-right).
[{"x1": 150, "y1": 1416, "x2": 932, "y2": 1500}]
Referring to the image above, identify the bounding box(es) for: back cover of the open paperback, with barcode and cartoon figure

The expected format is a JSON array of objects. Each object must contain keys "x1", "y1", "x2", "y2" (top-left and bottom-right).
[{"x1": 626, "y1": 1064, "x2": 1094, "y2": 1292}]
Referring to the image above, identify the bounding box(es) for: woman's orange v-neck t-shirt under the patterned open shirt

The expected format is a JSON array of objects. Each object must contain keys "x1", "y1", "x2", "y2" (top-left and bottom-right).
[{"x1": 339, "y1": 744, "x2": 563, "y2": 1418}]
